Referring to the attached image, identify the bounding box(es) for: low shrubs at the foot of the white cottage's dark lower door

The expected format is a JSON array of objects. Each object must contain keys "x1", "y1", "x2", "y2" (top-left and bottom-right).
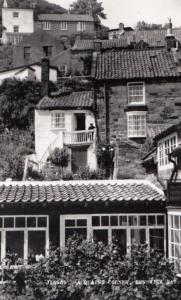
[{"x1": 74, "y1": 167, "x2": 106, "y2": 180}]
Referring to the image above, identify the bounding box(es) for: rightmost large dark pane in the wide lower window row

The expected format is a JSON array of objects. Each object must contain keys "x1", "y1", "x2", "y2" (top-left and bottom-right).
[{"x1": 149, "y1": 229, "x2": 164, "y2": 252}]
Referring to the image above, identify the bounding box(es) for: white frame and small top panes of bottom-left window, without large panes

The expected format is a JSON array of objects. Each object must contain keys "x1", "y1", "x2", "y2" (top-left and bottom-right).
[{"x1": 0, "y1": 215, "x2": 49, "y2": 264}]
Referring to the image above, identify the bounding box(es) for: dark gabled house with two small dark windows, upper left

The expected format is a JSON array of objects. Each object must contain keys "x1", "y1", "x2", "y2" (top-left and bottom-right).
[{"x1": 13, "y1": 30, "x2": 64, "y2": 67}]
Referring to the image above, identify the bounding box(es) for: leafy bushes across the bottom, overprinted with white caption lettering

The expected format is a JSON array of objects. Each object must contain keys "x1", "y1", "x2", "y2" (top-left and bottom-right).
[{"x1": 1, "y1": 240, "x2": 181, "y2": 300}]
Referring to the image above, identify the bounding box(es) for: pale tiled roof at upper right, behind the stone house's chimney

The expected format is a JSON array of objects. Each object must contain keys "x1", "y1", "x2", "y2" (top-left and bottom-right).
[{"x1": 121, "y1": 28, "x2": 181, "y2": 47}]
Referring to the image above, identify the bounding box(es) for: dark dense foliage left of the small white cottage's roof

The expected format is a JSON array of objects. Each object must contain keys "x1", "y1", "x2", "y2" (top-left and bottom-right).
[{"x1": 0, "y1": 79, "x2": 56, "y2": 130}]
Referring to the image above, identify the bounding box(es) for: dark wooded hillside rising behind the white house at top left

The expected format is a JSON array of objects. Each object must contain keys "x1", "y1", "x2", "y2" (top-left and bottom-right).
[{"x1": 0, "y1": 0, "x2": 66, "y2": 20}]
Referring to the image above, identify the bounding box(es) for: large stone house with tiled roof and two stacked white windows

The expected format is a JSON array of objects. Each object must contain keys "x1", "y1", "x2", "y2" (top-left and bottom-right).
[{"x1": 92, "y1": 28, "x2": 181, "y2": 178}]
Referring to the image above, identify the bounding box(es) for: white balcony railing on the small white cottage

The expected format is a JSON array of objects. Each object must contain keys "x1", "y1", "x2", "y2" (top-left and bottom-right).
[{"x1": 64, "y1": 129, "x2": 96, "y2": 145}]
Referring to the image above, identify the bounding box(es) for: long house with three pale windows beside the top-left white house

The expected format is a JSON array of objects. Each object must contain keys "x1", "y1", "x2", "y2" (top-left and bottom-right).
[{"x1": 38, "y1": 13, "x2": 94, "y2": 40}]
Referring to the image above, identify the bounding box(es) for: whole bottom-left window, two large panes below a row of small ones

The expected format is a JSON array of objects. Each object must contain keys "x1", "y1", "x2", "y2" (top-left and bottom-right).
[{"x1": 0, "y1": 215, "x2": 49, "y2": 261}]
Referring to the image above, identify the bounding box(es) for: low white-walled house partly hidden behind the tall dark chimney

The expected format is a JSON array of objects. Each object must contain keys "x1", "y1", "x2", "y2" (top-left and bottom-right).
[{"x1": 0, "y1": 62, "x2": 58, "y2": 84}]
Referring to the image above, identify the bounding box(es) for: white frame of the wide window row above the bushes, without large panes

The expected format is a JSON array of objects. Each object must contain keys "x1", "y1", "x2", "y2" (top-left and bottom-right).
[{"x1": 60, "y1": 213, "x2": 166, "y2": 254}]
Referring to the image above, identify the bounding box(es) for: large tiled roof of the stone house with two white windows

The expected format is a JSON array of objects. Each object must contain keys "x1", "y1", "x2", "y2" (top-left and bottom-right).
[{"x1": 92, "y1": 49, "x2": 179, "y2": 80}]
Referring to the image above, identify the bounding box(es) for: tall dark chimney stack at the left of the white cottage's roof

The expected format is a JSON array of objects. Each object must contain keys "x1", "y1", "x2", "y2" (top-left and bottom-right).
[{"x1": 41, "y1": 57, "x2": 50, "y2": 97}]
